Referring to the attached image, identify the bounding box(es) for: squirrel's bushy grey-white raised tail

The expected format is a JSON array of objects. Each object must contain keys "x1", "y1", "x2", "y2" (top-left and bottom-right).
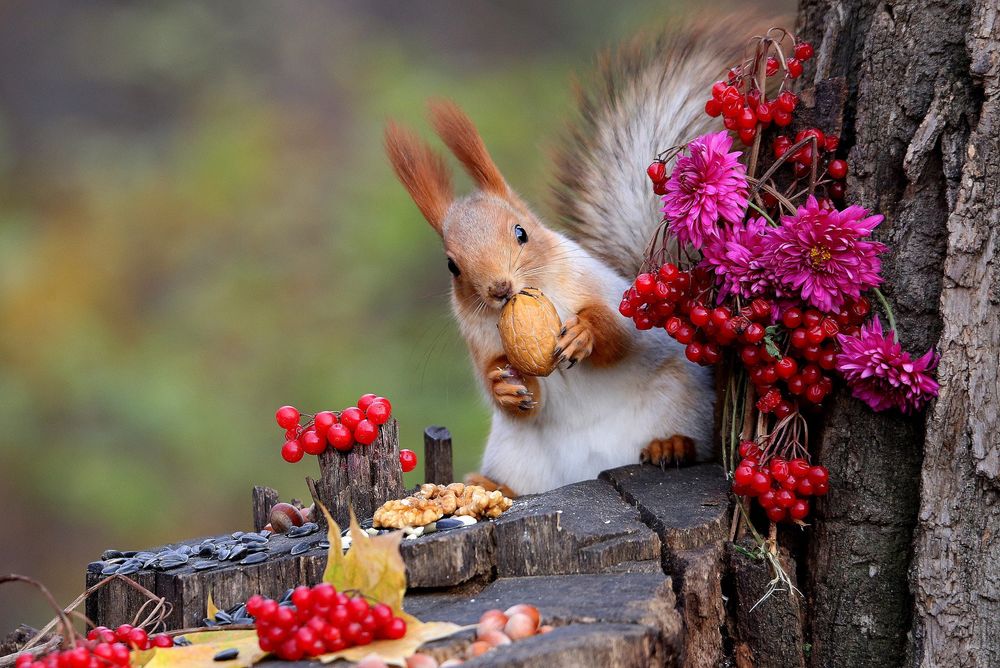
[{"x1": 555, "y1": 16, "x2": 760, "y2": 278}]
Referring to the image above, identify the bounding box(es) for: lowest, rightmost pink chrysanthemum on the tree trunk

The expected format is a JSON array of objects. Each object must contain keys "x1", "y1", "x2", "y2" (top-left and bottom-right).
[{"x1": 837, "y1": 316, "x2": 938, "y2": 413}]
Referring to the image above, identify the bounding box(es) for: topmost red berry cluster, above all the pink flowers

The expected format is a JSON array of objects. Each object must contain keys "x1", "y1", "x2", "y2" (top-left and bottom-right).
[{"x1": 705, "y1": 42, "x2": 813, "y2": 146}]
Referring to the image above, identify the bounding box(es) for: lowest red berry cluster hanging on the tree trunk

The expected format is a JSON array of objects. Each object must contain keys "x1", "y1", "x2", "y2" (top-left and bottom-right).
[{"x1": 733, "y1": 441, "x2": 830, "y2": 522}]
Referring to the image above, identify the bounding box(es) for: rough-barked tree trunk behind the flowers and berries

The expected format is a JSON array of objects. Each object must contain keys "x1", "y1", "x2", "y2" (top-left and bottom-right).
[{"x1": 799, "y1": 0, "x2": 1000, "y2": 666}]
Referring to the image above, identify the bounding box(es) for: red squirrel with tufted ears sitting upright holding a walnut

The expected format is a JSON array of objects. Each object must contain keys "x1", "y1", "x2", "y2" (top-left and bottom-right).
[{"x1": 385, "y1": 27, "x2": 744, "y2": 495}]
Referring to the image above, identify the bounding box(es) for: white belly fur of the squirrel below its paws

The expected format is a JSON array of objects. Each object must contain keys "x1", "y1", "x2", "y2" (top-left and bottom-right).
[{"x1": 482, "y1": 254, "x2": 714, "y2": 494}]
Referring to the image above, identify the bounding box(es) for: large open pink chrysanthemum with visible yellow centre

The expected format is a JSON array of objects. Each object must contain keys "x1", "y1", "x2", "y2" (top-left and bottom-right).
[{"x1": 767, "y1": 197, "x2": 885, "y2": 313}]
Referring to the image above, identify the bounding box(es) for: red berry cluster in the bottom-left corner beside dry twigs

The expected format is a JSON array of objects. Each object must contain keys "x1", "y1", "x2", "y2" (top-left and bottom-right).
[{"x1": 14, "y1": 624, "x2": 174, "y2": 668}]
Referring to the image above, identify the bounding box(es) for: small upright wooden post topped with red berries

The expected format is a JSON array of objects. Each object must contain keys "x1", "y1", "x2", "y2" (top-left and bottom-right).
[{"x1": 316, "y1": 420, "x2": 405, "y2": 526}]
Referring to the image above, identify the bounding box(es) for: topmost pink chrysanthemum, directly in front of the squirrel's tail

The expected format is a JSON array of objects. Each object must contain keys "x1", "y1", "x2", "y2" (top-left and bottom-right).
[{"x1": 663, "y1": 130, "x2": 747, "y2": 248}]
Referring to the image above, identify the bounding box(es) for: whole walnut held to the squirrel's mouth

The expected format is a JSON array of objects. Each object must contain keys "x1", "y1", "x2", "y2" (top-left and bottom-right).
[{"x1": 497, "y1": 288, "x2": 562, "y2": 376}]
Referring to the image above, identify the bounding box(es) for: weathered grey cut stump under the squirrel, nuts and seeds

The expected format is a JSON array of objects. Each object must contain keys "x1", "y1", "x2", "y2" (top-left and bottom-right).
[{"x1": 87, "y1": 466, "x2": 727, "y2": 668}]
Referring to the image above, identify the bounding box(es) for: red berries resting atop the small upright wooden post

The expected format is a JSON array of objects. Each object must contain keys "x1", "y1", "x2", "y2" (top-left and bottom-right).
[{"x1": 275, "y1": 394, "x2": 392, "y2": 463}]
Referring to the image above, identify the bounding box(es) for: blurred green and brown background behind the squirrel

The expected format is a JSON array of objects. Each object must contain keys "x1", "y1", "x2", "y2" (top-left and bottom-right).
[{"x1": 0, "y1": 0, "x2": 790, "y2": 634}]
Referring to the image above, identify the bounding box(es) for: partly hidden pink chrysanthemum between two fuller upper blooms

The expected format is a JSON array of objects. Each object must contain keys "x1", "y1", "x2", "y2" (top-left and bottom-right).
[{"x1": 701, "y1": 218, "x2": 770, "y2": 302}]
